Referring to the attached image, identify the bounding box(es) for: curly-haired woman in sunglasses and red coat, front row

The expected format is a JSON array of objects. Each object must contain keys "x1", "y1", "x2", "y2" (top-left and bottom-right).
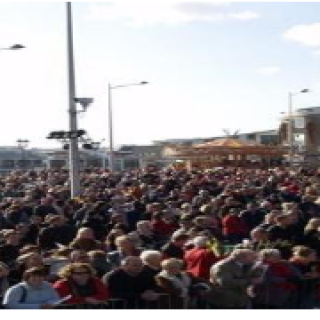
[{"x1": 54, "y1": 263, "x2": 109, "y2": 306}]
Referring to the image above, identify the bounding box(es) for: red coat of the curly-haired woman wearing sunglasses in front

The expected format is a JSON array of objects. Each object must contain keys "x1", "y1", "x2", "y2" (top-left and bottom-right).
[{"x1": 53, "y1": 278, "x2": 109, "y2": 304}]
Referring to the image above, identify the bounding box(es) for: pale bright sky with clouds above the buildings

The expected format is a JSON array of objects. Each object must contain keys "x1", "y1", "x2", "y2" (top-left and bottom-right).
[{"x1": 0, "y1": 0, "x2": 320, "y2": 147}]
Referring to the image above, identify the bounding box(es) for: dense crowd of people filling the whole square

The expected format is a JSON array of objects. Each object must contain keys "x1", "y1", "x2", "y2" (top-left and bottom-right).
[{"x1": 0, "y1": 167, "x2": 320, "y2": 309}]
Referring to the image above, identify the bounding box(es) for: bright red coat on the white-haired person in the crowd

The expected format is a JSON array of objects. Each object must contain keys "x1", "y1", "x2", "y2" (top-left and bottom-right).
[{"x1": 184, "y1": 248, "x2": 219, "y2": 280}]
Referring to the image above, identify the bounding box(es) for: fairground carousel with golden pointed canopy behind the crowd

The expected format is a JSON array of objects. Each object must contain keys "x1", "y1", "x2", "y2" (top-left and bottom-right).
[{"x1": 163, "y1": 138, "x2": 287, "y2": 170}]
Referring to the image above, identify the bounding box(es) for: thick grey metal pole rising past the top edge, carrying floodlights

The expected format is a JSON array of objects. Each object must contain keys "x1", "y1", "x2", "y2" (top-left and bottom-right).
[{"x1": 67, "y1": 2, "x2": 80, "y2": 198}]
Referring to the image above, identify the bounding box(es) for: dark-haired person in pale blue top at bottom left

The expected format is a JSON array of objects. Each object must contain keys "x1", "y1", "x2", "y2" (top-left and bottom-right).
[{"x1": 3, "y1": 267, "x2": 60, "y2": 309}]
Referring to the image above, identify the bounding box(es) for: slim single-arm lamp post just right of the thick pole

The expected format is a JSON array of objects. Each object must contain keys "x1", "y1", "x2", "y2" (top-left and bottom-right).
[{"x1": 108, "y1": 81, "x2": 148, "y2": 171}]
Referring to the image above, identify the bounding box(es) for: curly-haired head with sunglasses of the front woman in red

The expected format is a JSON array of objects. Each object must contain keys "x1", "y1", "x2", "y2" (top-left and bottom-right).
[{"x1": 58, "y1": 263, "x2": 95, "y2": 285}]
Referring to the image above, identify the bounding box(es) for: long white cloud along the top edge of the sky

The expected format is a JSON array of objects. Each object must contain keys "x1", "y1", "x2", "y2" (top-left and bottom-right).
[{"x1": 88, "y1": 0, "x2": 260, "y2": 26}]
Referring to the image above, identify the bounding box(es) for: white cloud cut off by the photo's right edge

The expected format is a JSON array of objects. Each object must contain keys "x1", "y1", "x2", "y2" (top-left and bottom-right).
[{"x1": 283, "y1": 23, "x2": 320, "y2": 47}]
